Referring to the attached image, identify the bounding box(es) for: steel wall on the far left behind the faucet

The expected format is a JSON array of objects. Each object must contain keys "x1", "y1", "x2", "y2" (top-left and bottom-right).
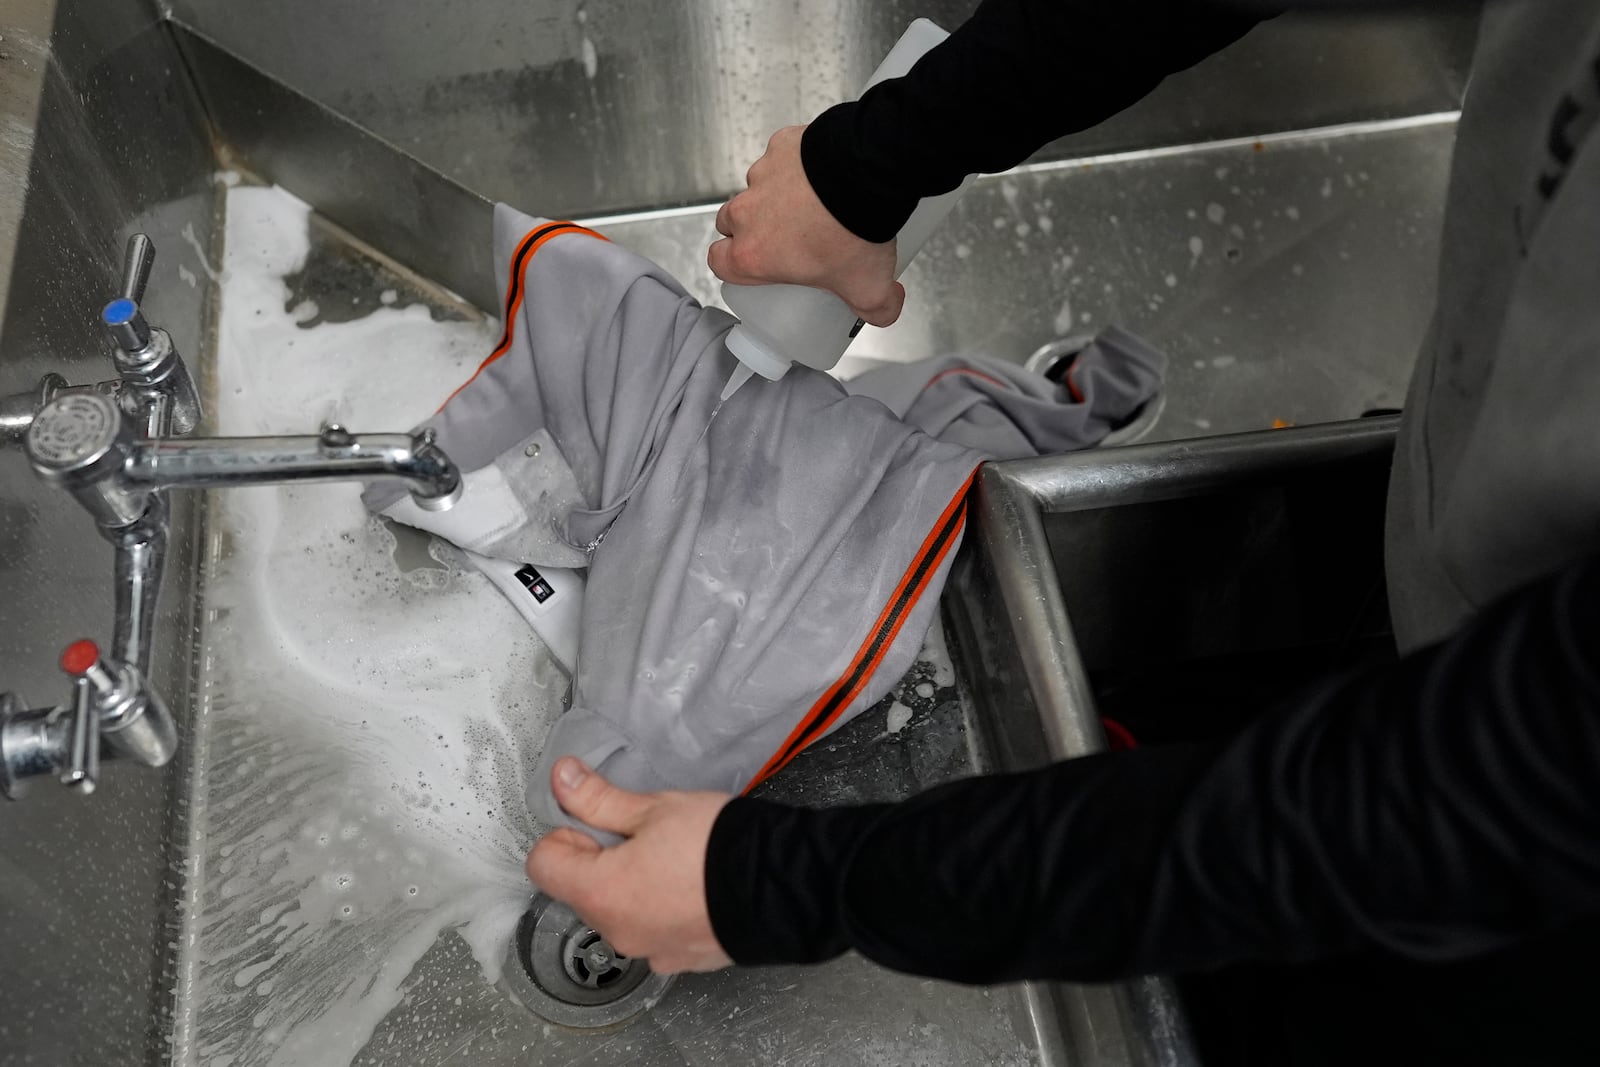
[{"x1": 0, "y1": 0, "x2": 214, "y2": 1064}]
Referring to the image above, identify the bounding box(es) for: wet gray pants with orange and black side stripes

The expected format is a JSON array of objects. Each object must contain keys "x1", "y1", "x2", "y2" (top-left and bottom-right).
[{"x1": 366, "y1": 206, "x2": 1158, "y2": 824}]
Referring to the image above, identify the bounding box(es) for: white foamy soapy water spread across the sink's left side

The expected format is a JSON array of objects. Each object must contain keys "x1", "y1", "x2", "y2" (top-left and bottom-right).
[{"x1": 179, "y1": 186, "x2": 566, "y2": 1067}]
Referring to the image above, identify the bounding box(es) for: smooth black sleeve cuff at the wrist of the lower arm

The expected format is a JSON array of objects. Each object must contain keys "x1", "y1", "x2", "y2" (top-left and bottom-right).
[{"x1": 706, "y1": 797, "x2": 888, "y2": 965}]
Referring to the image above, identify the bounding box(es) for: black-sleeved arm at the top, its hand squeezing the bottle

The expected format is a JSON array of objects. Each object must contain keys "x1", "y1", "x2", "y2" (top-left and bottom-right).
[{"x1": 802, "y1": 0, "x2": 1261, "y2": 242}]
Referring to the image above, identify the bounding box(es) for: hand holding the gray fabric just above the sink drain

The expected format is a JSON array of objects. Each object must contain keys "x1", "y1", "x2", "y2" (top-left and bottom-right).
[{"x1": 528, "y1": 757, "x2": 733, "y2": 974}]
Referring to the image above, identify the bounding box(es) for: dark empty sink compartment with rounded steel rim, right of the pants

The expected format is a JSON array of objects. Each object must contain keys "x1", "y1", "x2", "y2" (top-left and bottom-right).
[{"x1": 946, "y1": 416, "x2": 1398, "y2": 1062}]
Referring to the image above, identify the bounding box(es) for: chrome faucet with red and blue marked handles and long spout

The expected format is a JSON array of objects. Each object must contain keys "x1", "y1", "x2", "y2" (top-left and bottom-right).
[{"x1": 0, "y1": 234, "x2": 462, "y2": 798}]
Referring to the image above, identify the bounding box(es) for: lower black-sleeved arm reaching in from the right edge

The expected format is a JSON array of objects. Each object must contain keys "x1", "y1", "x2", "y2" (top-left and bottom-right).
[{"x1": 706, "y1": 560, "x2": 1600, "y2": 981}]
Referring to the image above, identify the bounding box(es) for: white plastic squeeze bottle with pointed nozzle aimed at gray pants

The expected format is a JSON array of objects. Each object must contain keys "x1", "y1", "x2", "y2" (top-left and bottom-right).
[{"x1": 722, "y1": 19, "x2": 973, "y2": 398}]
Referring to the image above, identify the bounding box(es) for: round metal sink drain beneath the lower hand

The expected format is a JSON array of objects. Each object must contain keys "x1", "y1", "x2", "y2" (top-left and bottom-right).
[{"x1": 504, "y1": 894, "x2": 672, "y2": 1030}]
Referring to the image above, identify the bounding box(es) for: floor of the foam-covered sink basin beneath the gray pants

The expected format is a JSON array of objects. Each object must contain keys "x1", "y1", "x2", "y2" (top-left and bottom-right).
[{"x1": 162, "y1": 186, "x2": 1040, "y2": 1067}]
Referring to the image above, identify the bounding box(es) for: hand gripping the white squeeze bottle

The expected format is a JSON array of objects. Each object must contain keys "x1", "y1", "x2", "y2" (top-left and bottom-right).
[{"x1": 706, "y1": 126, "x2": 906, "y2": 326}]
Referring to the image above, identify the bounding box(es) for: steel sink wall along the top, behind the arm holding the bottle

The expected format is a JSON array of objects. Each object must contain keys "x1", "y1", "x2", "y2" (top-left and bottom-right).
[{"x1": 162, "y1": 0, "x2": 1475, "y2": 216}]
